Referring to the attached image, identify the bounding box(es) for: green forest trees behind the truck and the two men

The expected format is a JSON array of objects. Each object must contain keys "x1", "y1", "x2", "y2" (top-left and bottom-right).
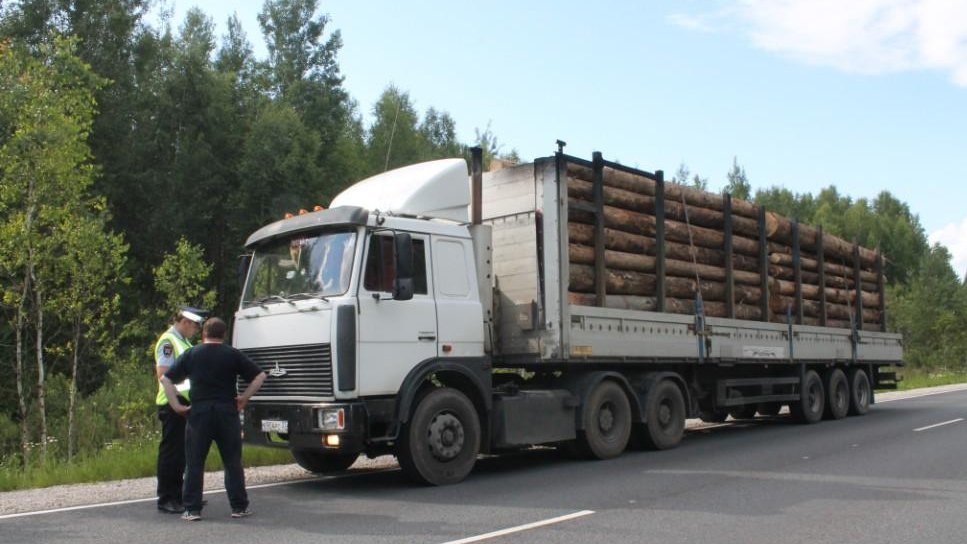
[{"x1": 0, "y1": 0, "x2": 967, "y2": 476}]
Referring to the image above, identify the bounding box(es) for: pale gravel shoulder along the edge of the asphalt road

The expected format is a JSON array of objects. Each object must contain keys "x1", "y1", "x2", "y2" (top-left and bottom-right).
[{"x1": 0, "y1": 384, "x2": 967, "y2": 516}]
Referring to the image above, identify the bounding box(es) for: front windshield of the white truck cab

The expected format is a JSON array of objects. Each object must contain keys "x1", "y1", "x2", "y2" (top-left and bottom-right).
[{"x1": 242, "y1": 232, "x2": 356, "y2": 307}]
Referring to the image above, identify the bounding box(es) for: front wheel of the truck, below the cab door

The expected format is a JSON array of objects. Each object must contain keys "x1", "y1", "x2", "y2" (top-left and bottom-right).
[{"x1": 396, "y1": 387, "x2": 480, "y2": 485}]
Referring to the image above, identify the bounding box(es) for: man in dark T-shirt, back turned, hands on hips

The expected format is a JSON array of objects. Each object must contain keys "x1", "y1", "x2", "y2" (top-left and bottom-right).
[{"x1": 161, "y1": 317, "x2": 265, "y2": 521}]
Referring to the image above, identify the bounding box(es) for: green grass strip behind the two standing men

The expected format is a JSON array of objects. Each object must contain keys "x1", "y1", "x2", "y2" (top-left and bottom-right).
[{"x1": 0, "y1": 442, "x2": 293, "y2": 491}]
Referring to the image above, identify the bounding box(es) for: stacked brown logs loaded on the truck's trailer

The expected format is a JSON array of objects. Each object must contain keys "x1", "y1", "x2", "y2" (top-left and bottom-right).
[{"x1": 566, "y1": 162, "x2": 883, "y2": 330}]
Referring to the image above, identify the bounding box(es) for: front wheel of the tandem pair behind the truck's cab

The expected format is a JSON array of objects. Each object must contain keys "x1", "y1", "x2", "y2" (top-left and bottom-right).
[{"x1": 571, "y1": 380, "x2": 632, "y2": 459}]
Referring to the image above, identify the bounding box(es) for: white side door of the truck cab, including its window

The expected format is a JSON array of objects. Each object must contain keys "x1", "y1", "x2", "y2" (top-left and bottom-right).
[{"x1": 358, "y1": 232, "x2": 438, "y2": 396}]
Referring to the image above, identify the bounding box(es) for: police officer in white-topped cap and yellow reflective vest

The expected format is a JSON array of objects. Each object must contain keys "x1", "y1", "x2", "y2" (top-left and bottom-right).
[{"x1": 154, "y1": 306, "x2": 206, "y2": 514}]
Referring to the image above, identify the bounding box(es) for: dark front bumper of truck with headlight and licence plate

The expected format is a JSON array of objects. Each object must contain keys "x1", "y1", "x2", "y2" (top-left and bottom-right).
[{"x1": 242, "y1": 402, "x2": 367, "y2": 453}]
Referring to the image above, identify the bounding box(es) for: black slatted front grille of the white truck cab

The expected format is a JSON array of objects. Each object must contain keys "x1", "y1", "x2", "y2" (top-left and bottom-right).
[{"x1": 239, "y1": 344, "x2": 333, "y2": 397}]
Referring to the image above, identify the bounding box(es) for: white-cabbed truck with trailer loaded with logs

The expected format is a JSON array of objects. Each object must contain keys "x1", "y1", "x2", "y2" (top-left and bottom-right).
[{"x1": 233, "y1": 147, "x2": 902, "y2": 485}]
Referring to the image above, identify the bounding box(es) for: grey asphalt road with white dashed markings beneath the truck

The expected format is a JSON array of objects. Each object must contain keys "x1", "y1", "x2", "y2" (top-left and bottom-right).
[{"x1": 0, "y1": 391, "x2": 967, "y2": 544}]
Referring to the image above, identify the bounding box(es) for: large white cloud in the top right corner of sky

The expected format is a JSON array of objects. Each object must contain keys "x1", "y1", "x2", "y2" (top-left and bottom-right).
[{"x1": 669, "y1": 0, "x2": 967, "y2": 87}]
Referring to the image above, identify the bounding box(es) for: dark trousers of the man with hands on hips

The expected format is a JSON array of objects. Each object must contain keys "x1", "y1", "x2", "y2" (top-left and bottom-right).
[{"x1": 183, "y1": 401, "x2": 248, "y2": 512}]
